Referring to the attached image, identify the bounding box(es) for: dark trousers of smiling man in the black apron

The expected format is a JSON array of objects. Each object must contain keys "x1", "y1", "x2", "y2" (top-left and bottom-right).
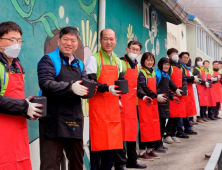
[{"x1": 39, "y1": 123, "x2": 84, "y2": 170}]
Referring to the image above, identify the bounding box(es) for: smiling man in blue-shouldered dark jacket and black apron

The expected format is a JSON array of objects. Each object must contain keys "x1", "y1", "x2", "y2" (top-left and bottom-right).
[{"x1": 38, "y1": 27, "x2": 88, "y2": 170}]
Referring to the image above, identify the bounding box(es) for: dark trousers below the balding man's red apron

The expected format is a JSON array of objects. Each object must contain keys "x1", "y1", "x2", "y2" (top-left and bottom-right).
[{"x1": 90, "y1": 150, "x2": 116, "y2": 170}]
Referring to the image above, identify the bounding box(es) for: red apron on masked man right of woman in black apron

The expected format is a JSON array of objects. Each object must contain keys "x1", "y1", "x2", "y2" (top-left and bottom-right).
[{"x1": 170, "y1": 67, "x2": 187, "y2": 118}]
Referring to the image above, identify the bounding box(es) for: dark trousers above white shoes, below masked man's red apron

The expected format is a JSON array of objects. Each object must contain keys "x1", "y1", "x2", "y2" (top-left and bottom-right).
[{"x1": 165, "y1": 117, "x2": 180, "y2": 137}]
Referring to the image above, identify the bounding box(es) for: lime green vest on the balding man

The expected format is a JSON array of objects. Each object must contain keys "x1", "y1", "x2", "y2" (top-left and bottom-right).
[{"x1": 93, "y1": 48, "x2": 121, "y2": 80}]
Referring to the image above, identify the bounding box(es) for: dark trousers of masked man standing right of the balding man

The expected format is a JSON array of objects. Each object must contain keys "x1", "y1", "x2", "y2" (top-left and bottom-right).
[{"x1": 114, "y1": 141, "x2": 138, "y2": 169}]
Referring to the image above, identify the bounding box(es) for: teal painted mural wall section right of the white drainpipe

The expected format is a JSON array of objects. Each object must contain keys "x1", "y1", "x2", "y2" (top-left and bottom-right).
[{"x1": 106, "y1": 0, "x2": 167, "y2": 63}]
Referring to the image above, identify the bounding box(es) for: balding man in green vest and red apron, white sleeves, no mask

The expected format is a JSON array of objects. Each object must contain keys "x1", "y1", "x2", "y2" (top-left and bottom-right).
[{"x1": 86, "y1": 29, "x2": 124, "y2": 170}]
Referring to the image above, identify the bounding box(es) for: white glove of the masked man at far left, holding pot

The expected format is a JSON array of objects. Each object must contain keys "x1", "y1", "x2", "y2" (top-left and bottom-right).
[{"x1": 25, "y1": 96, "x2": 43, "y2": 120}]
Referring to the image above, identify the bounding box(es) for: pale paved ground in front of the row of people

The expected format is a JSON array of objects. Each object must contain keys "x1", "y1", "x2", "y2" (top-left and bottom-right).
[{"x1": 132, "y1": 114, "x2": 222, "y2": 170}]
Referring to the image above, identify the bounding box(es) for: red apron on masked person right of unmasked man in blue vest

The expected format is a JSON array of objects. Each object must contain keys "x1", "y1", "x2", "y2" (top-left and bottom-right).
[{"x1": 197, "y1": 70, "x2": 208, "y2": 106}]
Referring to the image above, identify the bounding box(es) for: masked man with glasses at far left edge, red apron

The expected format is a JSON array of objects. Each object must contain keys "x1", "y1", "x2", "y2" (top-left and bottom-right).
[{"x1": 0, "y1": 21, "x2": 42, "y2": 170}]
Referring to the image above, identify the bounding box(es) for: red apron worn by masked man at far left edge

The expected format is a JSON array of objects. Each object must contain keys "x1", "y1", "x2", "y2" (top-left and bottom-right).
[{"x1": 0, "y1": 62, "x2": 32, "y2": 170}]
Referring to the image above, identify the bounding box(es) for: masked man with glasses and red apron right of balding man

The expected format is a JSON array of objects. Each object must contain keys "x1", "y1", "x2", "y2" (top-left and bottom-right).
[{"x1": 114, "y1": 41, "x2": 147, "y2": 170}]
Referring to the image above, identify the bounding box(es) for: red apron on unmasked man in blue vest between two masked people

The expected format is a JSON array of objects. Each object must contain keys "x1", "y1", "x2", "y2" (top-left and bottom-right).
[{"x1": 186, "y1": 69, "x2": 197, "y2": 117}]
